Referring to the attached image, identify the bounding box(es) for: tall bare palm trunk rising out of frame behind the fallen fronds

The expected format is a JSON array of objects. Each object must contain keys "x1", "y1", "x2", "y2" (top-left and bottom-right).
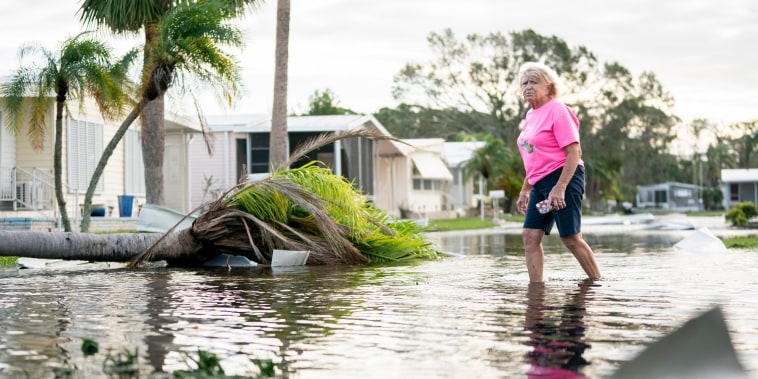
[{"x1": 269, "y1": 0, "x2": 290, "y2": 169}]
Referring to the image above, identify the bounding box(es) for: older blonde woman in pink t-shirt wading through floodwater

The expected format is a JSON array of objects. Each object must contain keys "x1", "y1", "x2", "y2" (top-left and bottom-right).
[{"x1": 516, "y1": 62, "x2": 600, "y2": 282}]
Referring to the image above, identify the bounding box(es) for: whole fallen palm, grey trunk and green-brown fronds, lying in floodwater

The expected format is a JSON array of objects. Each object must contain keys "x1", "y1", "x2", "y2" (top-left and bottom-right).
[{"x1": 0, "y1": 130, "x2": 438, "y2": 266}]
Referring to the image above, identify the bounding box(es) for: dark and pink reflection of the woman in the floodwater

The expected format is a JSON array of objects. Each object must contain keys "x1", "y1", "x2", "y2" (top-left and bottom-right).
[{"x1": 524, "y1": 280, "x2": 593, "y2": 379}]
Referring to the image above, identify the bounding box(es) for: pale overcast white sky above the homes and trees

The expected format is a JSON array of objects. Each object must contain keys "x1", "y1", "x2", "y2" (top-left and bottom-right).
[{"x1": 0, "y1": 0, "x2": 758, "y2": 124}]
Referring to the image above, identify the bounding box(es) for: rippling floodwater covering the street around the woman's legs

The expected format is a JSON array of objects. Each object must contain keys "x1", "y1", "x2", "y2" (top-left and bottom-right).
[{"x1": 0, "y1": 233, "x2": 758, "y2": 379}]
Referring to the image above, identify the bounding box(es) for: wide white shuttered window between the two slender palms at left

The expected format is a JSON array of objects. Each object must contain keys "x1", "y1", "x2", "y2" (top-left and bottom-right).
[{"x1": 68, "y1": 119, "x2": 105, "y2": 193}]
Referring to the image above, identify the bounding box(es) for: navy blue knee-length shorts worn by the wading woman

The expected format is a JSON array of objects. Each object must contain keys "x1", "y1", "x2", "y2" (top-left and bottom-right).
[{"x1": 524, "y1": 166, "x2": 584, "y2": 237}]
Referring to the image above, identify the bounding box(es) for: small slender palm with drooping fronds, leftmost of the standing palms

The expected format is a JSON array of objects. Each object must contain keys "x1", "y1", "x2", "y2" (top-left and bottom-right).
[{"x1": 2, "y1": 33, "x2": 131, "y2": 231}]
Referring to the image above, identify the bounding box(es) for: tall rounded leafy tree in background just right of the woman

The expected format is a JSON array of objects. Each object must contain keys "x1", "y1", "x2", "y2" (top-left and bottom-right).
[{"x1": 574, "y1": 63, "x2": 687, "y2": 204}]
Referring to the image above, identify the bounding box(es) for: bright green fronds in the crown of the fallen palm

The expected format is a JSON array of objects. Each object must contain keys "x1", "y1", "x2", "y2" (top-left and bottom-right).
[{"x1": 229, "y1": 162, "x2": 438, "y2": 262}]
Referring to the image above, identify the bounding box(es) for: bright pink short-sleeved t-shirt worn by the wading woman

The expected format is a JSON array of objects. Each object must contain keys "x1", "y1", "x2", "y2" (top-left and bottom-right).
[{"x1": 517, "y1": 99, "x2": 584, "y2": 185}]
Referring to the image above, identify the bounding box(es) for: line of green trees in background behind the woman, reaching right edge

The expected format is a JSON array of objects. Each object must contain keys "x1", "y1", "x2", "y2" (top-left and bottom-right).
[{"x1": 375, "y1": 29, "x2": 758, "y2": 214}]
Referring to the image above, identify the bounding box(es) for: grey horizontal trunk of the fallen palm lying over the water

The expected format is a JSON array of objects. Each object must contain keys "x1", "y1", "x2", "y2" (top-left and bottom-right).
[{"x1": 0, "y1": 228, "x2": 201, "y2": 262}]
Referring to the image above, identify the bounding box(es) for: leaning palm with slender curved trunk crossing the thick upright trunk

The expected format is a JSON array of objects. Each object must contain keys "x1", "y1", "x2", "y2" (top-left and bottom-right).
[{"x1": 81, "y1": 2, "x2": 252, "y2": 232}]
